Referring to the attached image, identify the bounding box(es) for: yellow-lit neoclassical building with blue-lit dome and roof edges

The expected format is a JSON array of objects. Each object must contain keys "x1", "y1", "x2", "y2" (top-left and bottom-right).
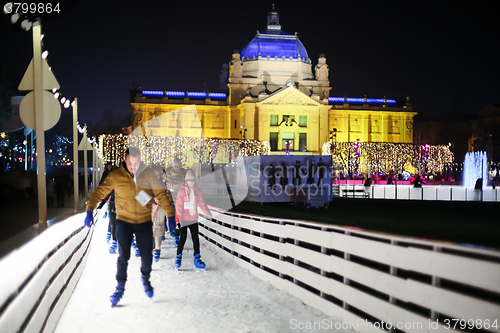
[{"x1": 130, "y1": 9, "x2": 416, "y2": 154}]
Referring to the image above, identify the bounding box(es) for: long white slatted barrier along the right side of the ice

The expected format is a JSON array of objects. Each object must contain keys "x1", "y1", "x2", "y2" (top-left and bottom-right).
[{"x1": 200, "y1": 209, "x2": 500, "y2": 332}]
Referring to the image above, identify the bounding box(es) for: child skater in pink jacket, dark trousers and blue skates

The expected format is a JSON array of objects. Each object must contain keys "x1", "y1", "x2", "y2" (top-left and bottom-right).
[{"x1": 175, "y1": 170, "x2": 212, "y2": 269}]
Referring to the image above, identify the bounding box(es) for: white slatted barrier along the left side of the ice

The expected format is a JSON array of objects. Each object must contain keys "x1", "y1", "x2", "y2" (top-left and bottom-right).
[{"x1": 0, "y1": 213, "x2": 97, "y2": 333}]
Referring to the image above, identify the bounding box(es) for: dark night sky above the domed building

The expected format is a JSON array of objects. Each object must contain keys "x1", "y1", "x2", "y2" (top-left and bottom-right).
[{"x1": 0, "y1": 0, "x2": 500, "y2": 128}]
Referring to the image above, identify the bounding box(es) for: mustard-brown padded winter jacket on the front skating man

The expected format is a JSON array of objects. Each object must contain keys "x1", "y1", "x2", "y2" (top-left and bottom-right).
[{"x1": 87, "y1": 163, "x2": 174, "y2": 223}]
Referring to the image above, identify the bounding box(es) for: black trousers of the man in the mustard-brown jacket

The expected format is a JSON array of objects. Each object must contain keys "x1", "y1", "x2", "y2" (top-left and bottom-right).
[{"x1": 116, "y1": 220, "x2": 153, "y2": 284}]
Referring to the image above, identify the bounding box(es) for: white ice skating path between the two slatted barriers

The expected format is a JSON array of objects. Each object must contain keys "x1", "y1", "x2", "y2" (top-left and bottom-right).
[{"x1": 55, "y1": 214, "x2": 354, "y2": 333}]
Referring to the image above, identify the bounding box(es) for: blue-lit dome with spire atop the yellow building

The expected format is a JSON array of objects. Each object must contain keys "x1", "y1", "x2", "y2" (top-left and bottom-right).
[{"x1": 240, "y1": 7, "x2": 311, "y2": 64}]
